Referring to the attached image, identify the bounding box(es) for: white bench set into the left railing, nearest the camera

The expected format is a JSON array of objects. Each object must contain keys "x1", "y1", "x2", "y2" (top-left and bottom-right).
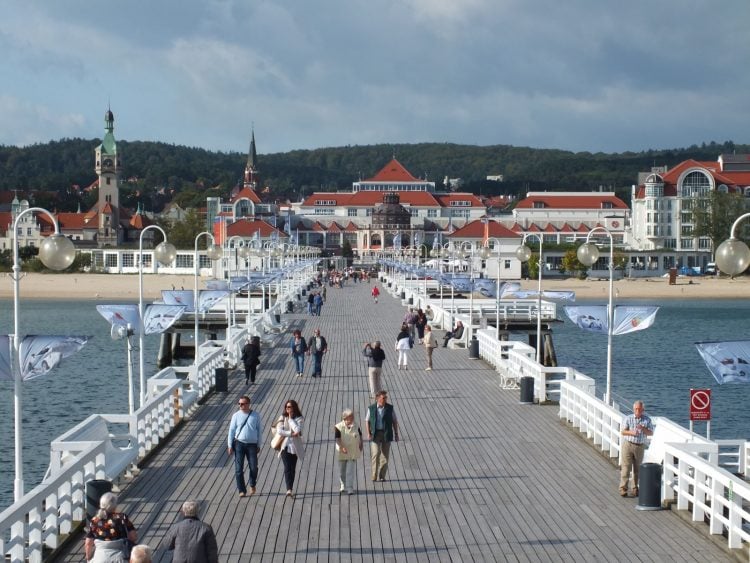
[{"x1": 47, "y1": 414, "x2": 138, "y2": 481}]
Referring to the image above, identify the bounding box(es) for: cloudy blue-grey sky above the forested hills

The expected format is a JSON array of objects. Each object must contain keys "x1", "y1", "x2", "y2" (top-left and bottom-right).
[{"x1": 0, "y1": 0, "x2": 750, "y2": 153}]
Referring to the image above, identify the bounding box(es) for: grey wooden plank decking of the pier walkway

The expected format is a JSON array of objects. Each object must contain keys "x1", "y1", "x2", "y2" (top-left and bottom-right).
[{"x1": 57, "y1": 281, "x2": 731, "y2": 562}]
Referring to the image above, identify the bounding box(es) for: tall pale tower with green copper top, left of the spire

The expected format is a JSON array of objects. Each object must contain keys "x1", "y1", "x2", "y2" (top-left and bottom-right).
[{"x1": 94, "y1": 109, "x2": 122, "y2": 247}]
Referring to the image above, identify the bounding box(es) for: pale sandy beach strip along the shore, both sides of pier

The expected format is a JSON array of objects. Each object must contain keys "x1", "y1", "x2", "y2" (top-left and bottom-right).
[{"x1": 0, "y1": 273, "x2": 750, "y2": 301}]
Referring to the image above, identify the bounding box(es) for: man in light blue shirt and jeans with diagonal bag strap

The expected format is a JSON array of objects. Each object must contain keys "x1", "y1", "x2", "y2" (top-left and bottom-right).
[{"x1": 227, "y1": 395, "x2": 263, "y2": 497}]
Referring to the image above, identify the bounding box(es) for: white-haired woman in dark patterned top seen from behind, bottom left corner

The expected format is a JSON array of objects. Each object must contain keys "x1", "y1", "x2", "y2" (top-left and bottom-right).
[{"x1": 84, "y1": 493, "x2": 138, "y2": 563}]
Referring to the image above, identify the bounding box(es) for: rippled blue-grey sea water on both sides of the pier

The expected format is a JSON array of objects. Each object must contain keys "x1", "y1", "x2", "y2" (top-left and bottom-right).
[{"x1": 0, "y1": 300, "x2": 750, "y2": 510}]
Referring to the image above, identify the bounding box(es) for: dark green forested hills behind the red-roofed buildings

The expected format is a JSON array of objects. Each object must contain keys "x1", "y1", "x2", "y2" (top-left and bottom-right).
[{"x1": 0, "y1": 139, "x2": 750, "y2": 210}]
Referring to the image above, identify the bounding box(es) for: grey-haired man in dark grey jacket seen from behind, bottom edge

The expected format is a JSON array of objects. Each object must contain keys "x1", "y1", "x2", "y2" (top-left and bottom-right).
[{"x1": 164, "y1": 500, "x2": 219, "y2": 563}]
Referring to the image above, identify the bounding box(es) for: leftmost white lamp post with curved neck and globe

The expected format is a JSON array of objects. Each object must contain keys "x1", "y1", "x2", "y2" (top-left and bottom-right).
[{"x1": 11, "y1": 207, "x2": 76, "y2": 502}]
